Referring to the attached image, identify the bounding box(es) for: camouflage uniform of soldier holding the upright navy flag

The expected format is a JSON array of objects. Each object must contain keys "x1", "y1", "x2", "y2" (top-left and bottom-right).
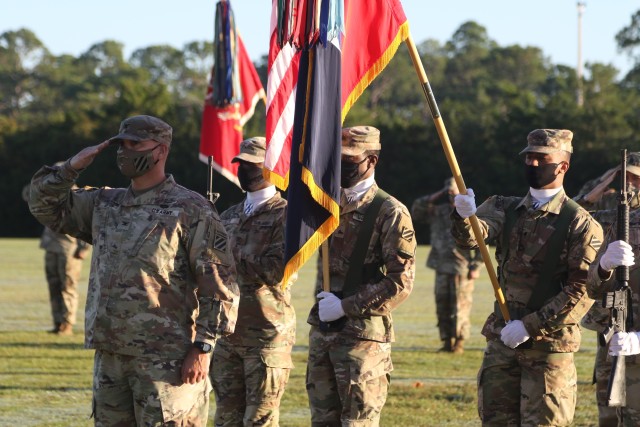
[{"x1": 306, "y1": 127, "x2": 416, "y2": 426}]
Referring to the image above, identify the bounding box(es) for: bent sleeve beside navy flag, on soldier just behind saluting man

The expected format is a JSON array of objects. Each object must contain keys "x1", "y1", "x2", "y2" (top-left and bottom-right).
[{"x1": 237, "y1": 209, "x2": 285, "y2": 286}]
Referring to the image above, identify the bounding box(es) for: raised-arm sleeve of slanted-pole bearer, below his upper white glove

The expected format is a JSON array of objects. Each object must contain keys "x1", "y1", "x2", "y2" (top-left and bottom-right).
[{"x1": 451, "y1": 196, "x2": 505, "y2": 249}]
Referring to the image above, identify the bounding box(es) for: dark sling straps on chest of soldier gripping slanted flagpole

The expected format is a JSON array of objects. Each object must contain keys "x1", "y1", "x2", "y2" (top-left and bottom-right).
[{"x1": 500, "y1": 199, "x2": 580, "y2": 311}]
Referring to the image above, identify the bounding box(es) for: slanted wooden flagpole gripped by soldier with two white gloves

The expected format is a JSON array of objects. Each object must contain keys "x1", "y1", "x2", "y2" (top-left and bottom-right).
[{"x1": 405, "y1": 34, "x2": 511, "y2": 321}]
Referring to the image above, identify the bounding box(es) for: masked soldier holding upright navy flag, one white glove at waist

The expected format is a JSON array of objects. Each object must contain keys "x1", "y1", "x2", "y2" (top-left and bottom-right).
[{"x1": 306, "y1": 126, "x2": 416, "y2": 427}]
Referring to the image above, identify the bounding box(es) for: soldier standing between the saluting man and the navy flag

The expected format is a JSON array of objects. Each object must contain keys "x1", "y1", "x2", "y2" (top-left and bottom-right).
[{"x1": 210, "y1": 137, "x2": 296, "y2": 427}]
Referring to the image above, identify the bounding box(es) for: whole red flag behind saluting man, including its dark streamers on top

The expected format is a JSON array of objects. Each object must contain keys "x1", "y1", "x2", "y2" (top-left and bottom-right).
[{"x1": 199, "y1": 0, "x2": 266, "y2": 186}]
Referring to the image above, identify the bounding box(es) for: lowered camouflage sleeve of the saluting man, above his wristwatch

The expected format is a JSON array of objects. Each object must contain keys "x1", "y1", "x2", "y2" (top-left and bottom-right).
[{"x1": 189, "y1": 208, "x2": 240, "y2": 345}]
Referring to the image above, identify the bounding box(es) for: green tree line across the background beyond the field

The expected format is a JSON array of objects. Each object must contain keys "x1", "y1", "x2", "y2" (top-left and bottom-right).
[{"x1": 0, "y1": 11, "x2": 640, "y2": 242}]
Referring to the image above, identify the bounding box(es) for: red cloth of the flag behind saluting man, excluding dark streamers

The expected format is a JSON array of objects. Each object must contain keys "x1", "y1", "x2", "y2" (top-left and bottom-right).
[{"x1": 200, "y1": 30, "x2": 266, "y2": 186}]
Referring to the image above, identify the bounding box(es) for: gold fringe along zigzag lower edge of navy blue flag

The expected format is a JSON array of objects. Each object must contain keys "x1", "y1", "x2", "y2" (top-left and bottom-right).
[{"x1": 282, "y1": 167, "x2": 340, "y2": 287}]
